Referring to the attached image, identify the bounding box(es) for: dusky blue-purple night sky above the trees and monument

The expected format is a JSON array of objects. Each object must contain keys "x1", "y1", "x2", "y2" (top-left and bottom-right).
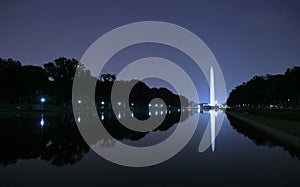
[{"x1": 0, "y1": 0, "x2": 300, "y2": 101}]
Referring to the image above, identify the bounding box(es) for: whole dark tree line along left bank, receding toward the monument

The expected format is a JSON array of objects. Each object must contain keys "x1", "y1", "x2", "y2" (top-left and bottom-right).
[{"x1": 0, "y1": 57, "x2": 188, "y2": 107}]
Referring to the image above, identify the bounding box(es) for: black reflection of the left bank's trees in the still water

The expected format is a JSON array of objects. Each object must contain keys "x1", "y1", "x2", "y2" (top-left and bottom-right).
[{"x1": 0, "y1": 111, "x2": 190, "y2": 166}]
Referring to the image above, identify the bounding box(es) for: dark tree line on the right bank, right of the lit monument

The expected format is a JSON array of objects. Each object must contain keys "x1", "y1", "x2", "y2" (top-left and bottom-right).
[{"x1": 227, "y1": 66, "x2": 300, "y2": 109}]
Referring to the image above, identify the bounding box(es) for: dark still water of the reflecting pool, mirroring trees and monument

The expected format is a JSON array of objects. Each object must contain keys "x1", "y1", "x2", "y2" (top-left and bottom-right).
[{"x1": 0, "y1": 112, "x2": 300, "y2": 186}]
